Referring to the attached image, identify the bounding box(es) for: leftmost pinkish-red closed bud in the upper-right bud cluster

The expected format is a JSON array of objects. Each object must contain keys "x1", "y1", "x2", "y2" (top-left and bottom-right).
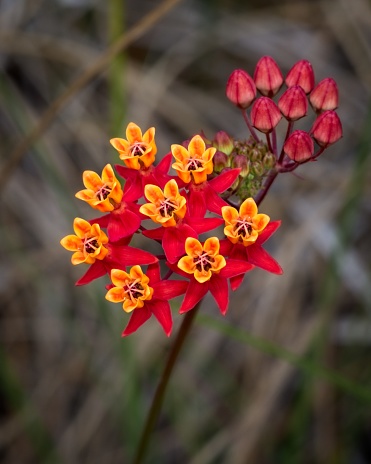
[{"x1": 226, "y1": 69, "x2": 256, "y2": 109}]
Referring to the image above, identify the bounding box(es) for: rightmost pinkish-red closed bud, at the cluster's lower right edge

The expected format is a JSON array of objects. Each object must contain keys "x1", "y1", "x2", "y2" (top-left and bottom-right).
[{"x1": 310, "y1": 110, "x2": 343, "y2": 147}]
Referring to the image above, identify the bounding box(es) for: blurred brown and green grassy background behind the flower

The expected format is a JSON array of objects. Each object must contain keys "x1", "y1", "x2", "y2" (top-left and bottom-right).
[{"x1": 0, "y1": 0, "x2": 371, "y2": 464}]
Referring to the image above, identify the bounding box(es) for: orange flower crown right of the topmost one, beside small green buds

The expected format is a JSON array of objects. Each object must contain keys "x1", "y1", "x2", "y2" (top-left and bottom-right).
[{"x1": 171, "y1": 135, "x2": 216, "y2": 184}]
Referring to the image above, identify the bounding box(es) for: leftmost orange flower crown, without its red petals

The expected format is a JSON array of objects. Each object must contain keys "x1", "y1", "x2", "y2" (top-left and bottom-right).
[{"x1": 60, "y1": 218, "x2": 108, "y2": 265}]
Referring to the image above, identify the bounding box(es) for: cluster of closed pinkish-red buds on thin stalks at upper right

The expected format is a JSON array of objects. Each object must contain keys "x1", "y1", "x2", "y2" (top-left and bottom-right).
[{"x1": 226, "y1": 56, "x2": 342, "y2": 170}]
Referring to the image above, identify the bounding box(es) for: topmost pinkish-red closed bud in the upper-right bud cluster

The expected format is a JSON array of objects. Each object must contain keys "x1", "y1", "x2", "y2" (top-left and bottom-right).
[{"x1": 254, "y1": 56, "x2": 283, "y2": 97}]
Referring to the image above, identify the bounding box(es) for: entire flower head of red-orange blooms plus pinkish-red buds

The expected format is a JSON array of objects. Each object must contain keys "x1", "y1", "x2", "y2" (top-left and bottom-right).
[{"x1": 61, "y1": 57, "x2": 341, "y2": 336}]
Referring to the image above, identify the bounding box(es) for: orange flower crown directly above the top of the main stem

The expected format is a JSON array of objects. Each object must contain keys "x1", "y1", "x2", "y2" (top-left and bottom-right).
[{"x1": 178, "y1": 237, "x2": 226, "y2": 283}]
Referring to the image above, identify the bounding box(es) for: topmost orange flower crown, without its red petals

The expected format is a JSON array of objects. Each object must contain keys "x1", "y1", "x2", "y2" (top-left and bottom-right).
[{"x1": 110, "y1": 122, "x2": 157, "y2": 170}]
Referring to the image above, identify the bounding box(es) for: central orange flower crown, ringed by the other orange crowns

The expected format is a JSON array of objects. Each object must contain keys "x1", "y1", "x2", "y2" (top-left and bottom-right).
[{"x1": 139, "y1": 179, "x2": 187, "y2": 227}]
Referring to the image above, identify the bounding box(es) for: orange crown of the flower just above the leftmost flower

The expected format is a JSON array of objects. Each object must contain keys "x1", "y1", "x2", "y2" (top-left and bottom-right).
[{"x1": 75, "y1": 164, "x2": 123, "y2": 212}]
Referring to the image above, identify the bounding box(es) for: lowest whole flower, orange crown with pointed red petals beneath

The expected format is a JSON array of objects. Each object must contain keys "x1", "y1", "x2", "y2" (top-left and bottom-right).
[{"x1": 106, "y1": 263, "x2": 188, "y2": 336}]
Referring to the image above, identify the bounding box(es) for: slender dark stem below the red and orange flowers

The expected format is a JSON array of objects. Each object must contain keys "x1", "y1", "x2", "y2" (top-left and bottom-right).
[{"x1": 133, "y1": 302, "x2": 201, "y2": 464}]
